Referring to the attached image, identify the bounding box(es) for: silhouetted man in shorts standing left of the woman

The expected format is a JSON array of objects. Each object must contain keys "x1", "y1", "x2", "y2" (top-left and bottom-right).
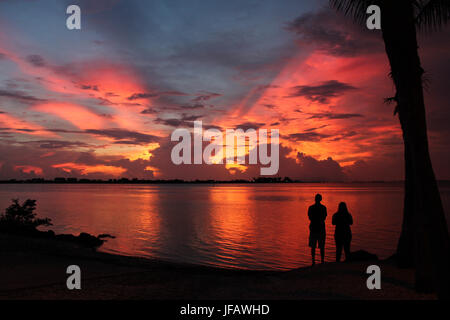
[{"x1": 308, "y1": 194, "x2": 327, "y2": 265}]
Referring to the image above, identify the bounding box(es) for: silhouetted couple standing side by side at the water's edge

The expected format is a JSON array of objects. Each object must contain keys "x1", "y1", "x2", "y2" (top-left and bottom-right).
[{"x1": 308, "y1": 194, "x2": 353, "y2": 265}]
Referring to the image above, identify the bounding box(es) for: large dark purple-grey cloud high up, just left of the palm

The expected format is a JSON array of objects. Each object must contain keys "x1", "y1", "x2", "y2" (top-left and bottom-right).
[{"x1": 287, "y1": 8, "x2": 384, "y2": 56}]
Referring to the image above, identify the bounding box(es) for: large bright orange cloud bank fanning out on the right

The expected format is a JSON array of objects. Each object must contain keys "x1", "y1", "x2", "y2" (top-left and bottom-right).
[{"x1": 219, "y1": 52, "x2": 399, "y2": 168}]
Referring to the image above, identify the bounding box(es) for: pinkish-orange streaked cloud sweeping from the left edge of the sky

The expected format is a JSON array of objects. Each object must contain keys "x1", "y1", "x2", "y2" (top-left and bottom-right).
[{"x1": 0, "y1": 43, "x2": 156, "y2": 130}]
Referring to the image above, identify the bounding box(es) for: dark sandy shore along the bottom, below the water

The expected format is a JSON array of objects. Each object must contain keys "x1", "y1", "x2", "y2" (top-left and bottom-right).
[{"x1": 0, "y1": 235, "x2": 436, "y2": 300}]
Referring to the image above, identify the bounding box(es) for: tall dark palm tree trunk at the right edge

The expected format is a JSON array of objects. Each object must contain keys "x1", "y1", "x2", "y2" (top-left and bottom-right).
[{"x1": 381, "y1": 0, "x2": 450, "y2": 298}]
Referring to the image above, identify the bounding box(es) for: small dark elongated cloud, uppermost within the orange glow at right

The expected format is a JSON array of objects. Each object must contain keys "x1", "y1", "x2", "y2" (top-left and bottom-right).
[{"x1": 290, "y1": 80, "x2": 356, "y2": 104}]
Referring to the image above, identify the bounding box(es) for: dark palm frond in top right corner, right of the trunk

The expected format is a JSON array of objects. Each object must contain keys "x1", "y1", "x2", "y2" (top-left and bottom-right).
[{"x1": 416, "y1": 0, "x2": 450, "y2": 31}]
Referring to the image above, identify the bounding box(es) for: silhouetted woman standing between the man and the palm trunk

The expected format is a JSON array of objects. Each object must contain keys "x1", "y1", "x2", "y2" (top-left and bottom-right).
[{"x1": 332, "y1": 202, "x2": 353, "y2": 262}]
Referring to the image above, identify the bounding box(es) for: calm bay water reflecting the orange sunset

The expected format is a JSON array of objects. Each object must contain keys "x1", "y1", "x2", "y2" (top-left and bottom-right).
[{"x1": 0, "y1": 184, "x2": 450, "y2": 269}]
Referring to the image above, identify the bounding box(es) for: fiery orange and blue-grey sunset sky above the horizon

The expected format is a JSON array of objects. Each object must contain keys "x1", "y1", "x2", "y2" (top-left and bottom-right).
[{"x1": 0, "y1": 0, "x2": 450, "y2": 181}]
